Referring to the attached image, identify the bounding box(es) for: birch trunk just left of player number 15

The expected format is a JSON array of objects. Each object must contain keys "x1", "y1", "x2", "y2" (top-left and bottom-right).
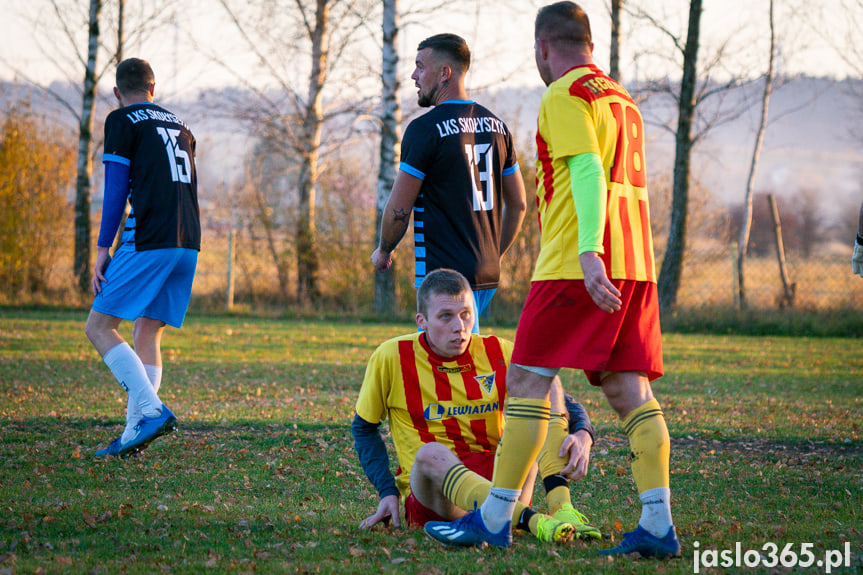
[{"x1": 73, "y1": 0, "x2": 102, "y2": 292}]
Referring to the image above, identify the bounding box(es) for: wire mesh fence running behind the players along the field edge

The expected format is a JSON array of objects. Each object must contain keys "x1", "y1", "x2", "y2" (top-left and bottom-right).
[{"x1": 186, "y1": 226, "x2": 863, "y2": 310}]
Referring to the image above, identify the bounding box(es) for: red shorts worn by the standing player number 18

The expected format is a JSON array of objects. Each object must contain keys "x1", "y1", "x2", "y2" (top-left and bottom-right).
[{"x1": 512, "y1": 280, "x2": 662, "y2": 385}]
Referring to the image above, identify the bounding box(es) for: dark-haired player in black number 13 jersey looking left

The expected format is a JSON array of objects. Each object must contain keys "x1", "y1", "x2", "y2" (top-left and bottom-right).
[{"x1": 372, "y1": 34, "x2": 527, "y2": 333}]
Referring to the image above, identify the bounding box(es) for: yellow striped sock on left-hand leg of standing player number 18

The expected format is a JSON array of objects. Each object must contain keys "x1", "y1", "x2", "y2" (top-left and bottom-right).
[{"x1": 491, "y1": 397, "x2": 551, "y2": 490}]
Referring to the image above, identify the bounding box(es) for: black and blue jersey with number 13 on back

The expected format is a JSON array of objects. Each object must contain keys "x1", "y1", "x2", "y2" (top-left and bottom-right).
[{"x1": 399, "y1": 100, "x2": 518, "y2": 289}]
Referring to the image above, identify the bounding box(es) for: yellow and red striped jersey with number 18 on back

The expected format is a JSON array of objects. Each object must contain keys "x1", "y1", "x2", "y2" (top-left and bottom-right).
[{"x1": 532, "y1": 65, "x2": 656, "y2": 282}]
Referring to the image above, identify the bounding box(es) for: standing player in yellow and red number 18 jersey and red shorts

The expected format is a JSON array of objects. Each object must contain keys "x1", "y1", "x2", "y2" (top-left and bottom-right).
[{"x1": 426, "y1": 2, "x2": 680, "y2": 557}]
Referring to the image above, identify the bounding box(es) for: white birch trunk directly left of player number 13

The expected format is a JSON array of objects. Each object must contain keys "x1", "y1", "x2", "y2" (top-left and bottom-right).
[{"x1": 374, "y1": 0, "x2": 402, "y2": 315}]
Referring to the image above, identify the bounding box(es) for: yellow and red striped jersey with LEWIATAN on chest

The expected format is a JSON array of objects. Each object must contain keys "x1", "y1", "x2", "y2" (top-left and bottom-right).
[{"x1": 356, "y1": 332, "x2": 512, "y2": 497}]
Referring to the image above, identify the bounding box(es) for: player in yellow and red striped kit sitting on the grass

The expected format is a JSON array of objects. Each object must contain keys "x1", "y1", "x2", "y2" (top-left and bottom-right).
[{"x1": 351, "y1": 268, "x2": 600, "y2": 542}]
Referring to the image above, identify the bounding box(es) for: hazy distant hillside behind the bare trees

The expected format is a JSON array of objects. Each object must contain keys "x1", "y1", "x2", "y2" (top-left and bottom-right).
[{"x1": 0, "y1": 78, "x2": 863, "y2": 218}]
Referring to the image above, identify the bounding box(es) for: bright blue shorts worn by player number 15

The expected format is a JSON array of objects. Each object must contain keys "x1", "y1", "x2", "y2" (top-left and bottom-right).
[{"x1": 93, "y1": 245, "x2": 198, "y2": 328}]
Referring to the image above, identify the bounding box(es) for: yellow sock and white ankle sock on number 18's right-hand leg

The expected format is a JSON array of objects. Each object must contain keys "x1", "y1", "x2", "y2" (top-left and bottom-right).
[{"x1": 623, "y1": 399, "x2": 672, "y2": 537}]
